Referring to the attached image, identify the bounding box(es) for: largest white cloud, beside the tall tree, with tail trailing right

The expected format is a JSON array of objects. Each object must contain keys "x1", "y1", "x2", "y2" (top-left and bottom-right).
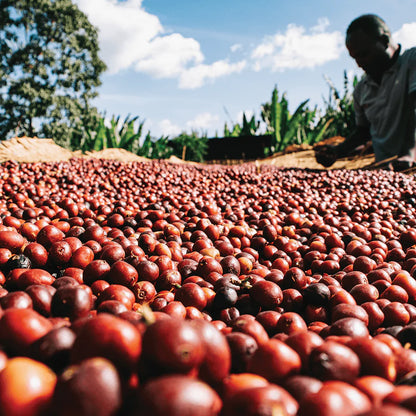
[{"x1": 76, "y1": 0, "x2": 244, "y2": 88}]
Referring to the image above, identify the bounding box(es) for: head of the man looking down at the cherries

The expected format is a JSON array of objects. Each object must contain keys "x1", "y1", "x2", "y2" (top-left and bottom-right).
[{"x1": 345, "y1": 14, "x2": 398, "y2": 80}]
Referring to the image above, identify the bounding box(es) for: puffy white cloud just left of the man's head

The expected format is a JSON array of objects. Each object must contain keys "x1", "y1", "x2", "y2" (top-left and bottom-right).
[{"x1": 251, "y1": 18, "x2": 344, "y2": 71}]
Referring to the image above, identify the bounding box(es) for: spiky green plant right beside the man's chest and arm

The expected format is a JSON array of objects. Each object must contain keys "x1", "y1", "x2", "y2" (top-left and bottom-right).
[{"x1": 322, "y1": 71, "x2": 358, "y2": 138}]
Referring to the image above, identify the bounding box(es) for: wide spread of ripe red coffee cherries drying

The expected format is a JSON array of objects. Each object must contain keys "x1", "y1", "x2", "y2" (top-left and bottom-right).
[{"x1": 0, "y1": 158, "x2": 416, "y2": 416}]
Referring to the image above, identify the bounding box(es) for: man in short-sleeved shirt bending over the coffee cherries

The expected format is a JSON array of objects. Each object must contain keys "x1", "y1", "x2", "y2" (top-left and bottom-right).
[{"x1": 315, "y1": 14, "x2": 416, "y2": 171}]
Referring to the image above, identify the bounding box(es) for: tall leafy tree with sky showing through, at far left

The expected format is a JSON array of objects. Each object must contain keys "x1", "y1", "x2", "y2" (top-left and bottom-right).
[{"x1": 0, "y1": 0, "x2": 106, "y2": 148}]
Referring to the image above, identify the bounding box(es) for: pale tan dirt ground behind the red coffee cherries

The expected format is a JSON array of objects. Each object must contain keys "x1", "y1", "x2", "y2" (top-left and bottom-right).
[{"x1": 0, "y1": 137, "x2": 374, "y2": 169}]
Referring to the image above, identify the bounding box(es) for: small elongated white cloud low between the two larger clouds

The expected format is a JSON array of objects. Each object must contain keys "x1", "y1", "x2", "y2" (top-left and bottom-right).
[{"x1": 179, "y1": 60, "x2": 246, "y2": 89}]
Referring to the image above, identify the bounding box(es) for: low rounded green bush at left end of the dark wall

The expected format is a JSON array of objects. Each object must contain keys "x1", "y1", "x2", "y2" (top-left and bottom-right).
[{"x1": 170, "y1": 130, "x2": 208, "y2": 162}]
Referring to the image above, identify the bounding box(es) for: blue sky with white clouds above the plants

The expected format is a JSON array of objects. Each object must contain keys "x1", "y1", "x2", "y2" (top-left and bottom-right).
[{"x1": 75, "y1": 0, "x2": 416, "y2": 137}]
